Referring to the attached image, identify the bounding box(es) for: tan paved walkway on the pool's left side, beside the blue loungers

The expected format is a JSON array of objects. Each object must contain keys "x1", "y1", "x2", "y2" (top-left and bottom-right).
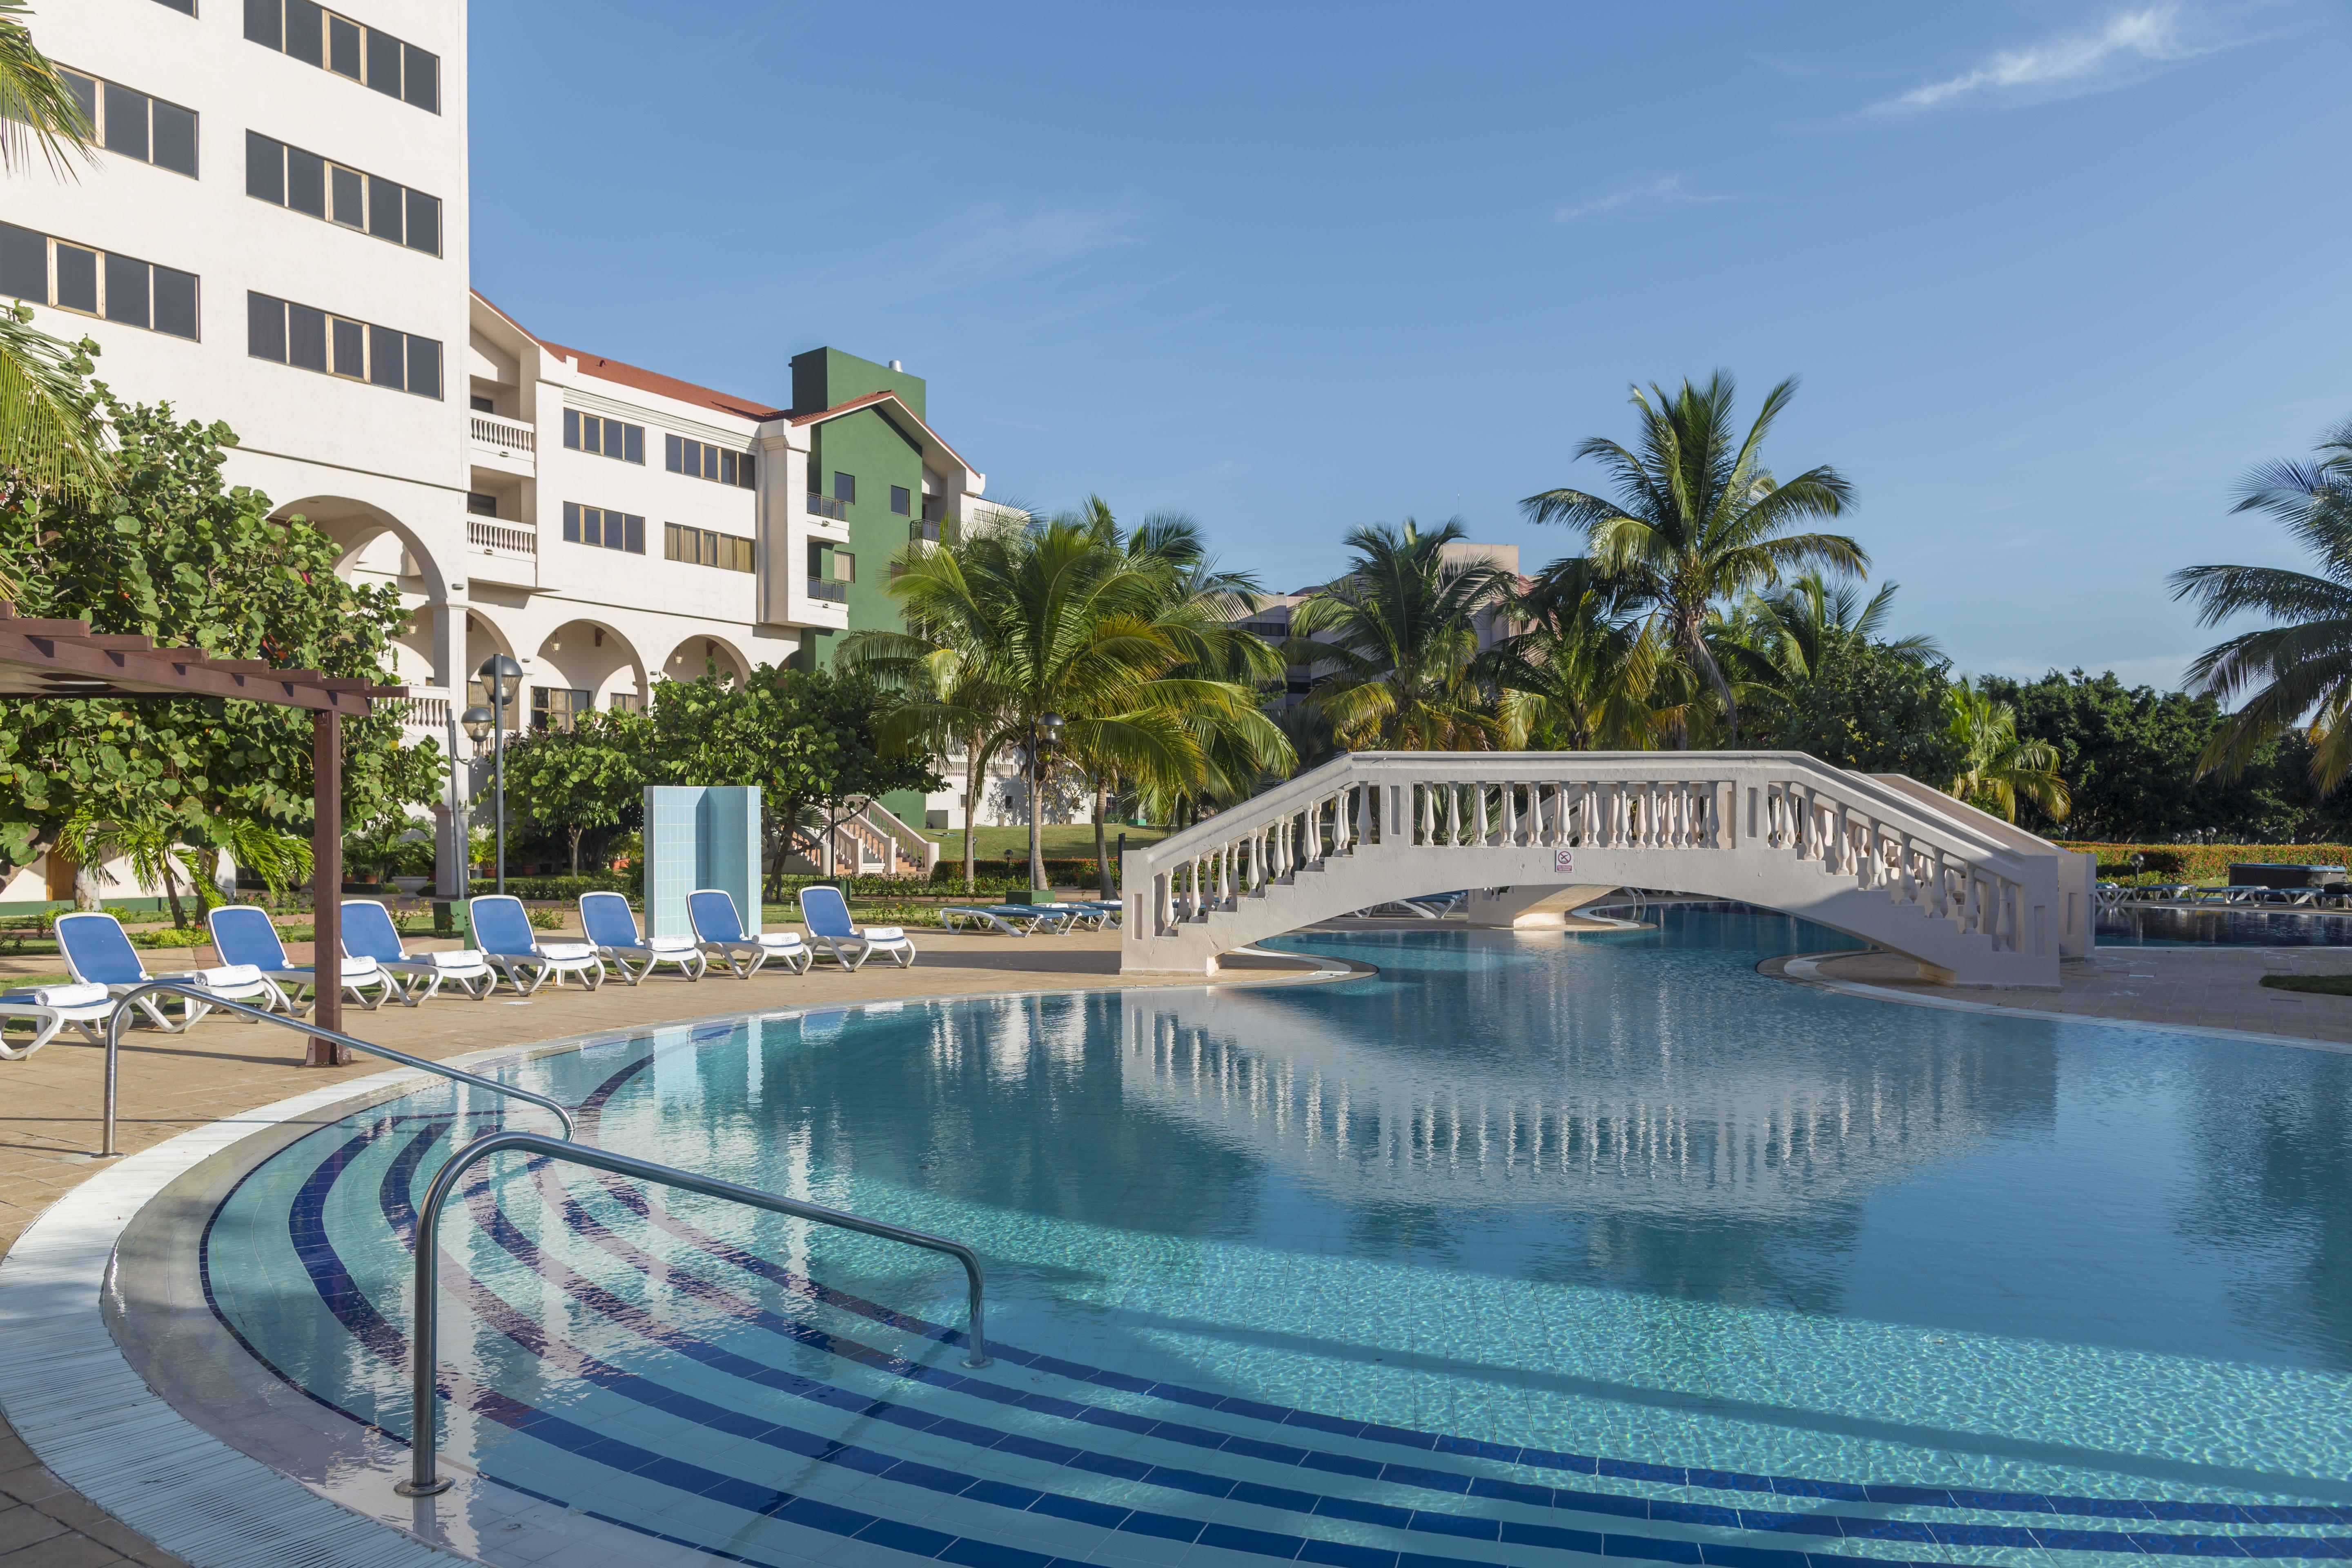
[{"x1": 0, "y1": 931, "x2": 1315, "y2": 1568}]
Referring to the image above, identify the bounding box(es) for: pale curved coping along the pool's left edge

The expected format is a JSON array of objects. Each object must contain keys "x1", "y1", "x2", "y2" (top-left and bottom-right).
[{"x1": 0, "y1": 947, "x2": 1378, "y2": 1568}]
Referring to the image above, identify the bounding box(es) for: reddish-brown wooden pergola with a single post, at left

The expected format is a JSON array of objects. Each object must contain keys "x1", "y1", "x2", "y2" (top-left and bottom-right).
[{"x1": 0, "y1": 599, "x2": 407, "y2": 1067}]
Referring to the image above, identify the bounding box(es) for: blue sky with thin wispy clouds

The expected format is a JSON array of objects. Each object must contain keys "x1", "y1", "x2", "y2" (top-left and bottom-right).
[{"x1": 473, "y1": 0, "x2": 2352, "y2": 684}]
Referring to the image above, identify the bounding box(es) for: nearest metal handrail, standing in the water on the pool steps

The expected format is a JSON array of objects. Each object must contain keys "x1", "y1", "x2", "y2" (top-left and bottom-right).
[{"x1": 393, "y1": 1133, "x2": 988, "y2": 1497}]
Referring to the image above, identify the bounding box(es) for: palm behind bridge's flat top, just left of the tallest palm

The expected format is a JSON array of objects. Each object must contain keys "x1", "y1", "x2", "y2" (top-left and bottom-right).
[{"x1": 1482, "y1": 555, "x2": 1668, "y2": 752}]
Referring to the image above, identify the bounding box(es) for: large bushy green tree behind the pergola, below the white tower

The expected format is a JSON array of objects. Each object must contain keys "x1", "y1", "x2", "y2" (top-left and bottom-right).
[{"x1": 0, "y1": 385, "x2": 442, "y2": 875}]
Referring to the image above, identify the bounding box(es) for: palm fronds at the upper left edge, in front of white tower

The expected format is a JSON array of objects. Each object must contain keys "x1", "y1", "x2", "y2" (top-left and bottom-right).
[{"x1": 0, "y1": 0, "x2": 113, "y2": 505}]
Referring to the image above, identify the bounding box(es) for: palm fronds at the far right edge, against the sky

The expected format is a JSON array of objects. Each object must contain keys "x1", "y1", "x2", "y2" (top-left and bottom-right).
[{"x1": 2173, "y1": 421, "x2": 2352, "y2": 792}]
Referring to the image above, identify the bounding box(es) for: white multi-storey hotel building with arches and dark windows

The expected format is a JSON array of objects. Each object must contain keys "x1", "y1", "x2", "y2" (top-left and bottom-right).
[{"x1": 0, "y1": 0, "x2": 1020, "y2": 903}]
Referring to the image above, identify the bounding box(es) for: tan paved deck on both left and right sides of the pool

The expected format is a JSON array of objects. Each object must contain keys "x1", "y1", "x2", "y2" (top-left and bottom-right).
[{"x1": 13, "y1": 929, "x2": 2352, "y2": 1568}]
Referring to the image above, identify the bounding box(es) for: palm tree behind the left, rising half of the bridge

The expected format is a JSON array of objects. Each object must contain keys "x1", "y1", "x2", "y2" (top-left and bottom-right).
[{"x1": 1287, "y1": 517, "x2": 1512, "y2": 752}]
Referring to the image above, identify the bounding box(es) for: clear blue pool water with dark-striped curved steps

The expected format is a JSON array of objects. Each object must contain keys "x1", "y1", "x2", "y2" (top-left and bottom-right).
[{"x1": 205, "y1": 910, "x2": 2352, "y2": 1568}]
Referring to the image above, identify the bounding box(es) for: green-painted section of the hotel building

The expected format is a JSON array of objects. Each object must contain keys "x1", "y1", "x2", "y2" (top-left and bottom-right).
[{"x1": 793, "y1": 348, "x2": 931, "y2": 828}]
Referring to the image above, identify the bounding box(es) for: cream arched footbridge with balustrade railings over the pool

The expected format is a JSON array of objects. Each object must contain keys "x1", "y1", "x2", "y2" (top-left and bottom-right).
[{"x1": 1120, "y1": 752, "x2": 2096, "y2": 987}]
